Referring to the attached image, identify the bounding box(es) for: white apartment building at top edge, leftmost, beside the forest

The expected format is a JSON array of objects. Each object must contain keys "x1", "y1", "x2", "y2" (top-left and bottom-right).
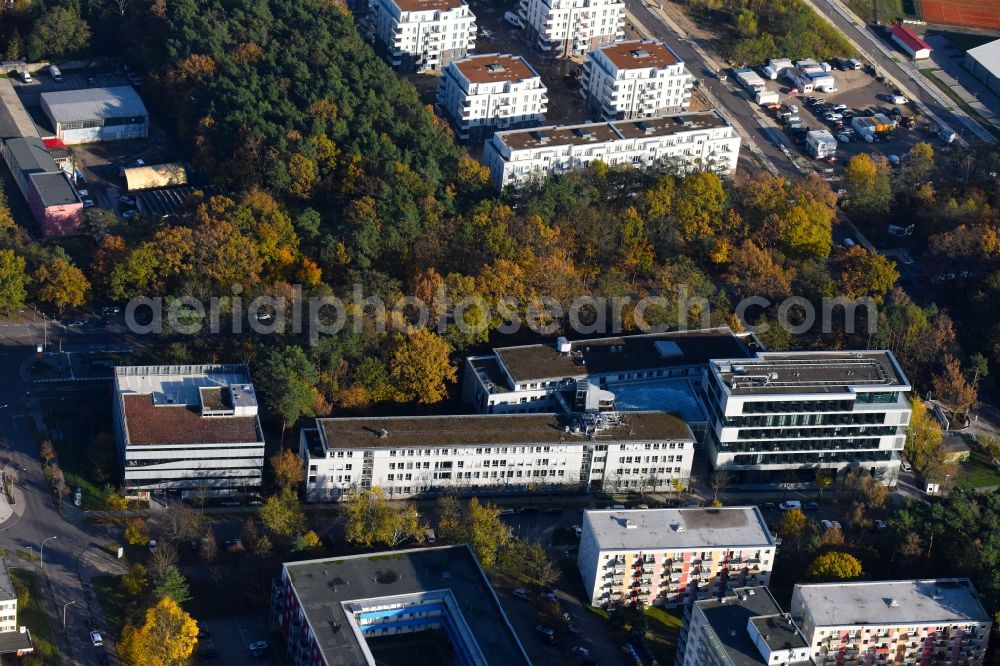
[{"x1": 370, "y1": 0, "x2": 476, "y2": 72}]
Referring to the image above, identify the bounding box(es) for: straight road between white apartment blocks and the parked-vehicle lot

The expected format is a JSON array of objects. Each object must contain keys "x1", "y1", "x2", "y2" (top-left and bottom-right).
[{"x1": 625, "y1": 0, "x2": 800, "y2": 177}]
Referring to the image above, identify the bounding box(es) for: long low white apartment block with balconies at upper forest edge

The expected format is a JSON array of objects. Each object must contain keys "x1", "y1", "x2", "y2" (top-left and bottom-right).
[{"x1": 483, "y1": 111, "x2": 740, "y2": 190}]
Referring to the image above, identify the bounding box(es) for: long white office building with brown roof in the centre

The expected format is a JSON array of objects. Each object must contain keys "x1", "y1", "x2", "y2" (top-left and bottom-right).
[{"x1": 299, "y1": 412, "x2": 694, "y2": 501}]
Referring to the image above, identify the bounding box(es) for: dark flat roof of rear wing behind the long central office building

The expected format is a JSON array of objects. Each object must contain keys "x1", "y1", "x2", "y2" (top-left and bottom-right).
[{"x1": 493, "y1": 327, "x2": 753, "y2": 382}]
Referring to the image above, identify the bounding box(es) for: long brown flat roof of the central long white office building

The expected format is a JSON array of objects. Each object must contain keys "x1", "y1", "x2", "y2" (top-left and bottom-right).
[{"x1": 316, "y1": 412, "x2": 692, "y2": 449}]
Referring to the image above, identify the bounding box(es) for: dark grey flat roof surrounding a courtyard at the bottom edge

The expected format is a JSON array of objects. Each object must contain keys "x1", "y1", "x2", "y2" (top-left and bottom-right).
[{"x1": 284, "y1": 545, "x2": 531, "y2": 666}]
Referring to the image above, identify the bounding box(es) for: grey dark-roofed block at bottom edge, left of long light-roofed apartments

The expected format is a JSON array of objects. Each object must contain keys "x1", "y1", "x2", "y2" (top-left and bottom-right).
[{"x1": 675, "y1": 586, "x2": 813, "y2": 666}]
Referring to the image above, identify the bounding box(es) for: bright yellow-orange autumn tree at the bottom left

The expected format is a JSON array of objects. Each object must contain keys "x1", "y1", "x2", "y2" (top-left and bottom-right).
[{"x1": 118, "y1": 597, "x2": 198, "y2": 666}]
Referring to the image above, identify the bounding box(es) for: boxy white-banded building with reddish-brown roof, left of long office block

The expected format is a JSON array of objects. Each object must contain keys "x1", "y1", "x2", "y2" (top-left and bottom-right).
[{"x1": 113, "y1": 365, "x2": 264, "y2": 497}]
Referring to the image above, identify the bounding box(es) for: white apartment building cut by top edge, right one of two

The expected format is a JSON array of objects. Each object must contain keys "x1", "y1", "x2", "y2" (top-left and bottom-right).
[{"x1": 518, "y1": 0, "x2": 625, "y2": 57}]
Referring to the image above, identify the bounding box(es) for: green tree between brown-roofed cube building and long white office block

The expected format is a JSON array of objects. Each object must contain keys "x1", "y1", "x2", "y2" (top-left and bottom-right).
[{"x1": 257, "y1": 345, "x2": 319, "y2": 441}]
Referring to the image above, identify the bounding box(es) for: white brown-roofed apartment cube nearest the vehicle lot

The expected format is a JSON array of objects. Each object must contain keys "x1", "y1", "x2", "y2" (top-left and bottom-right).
[{"x1": 580, "y1": 39, "x2": 694, "y2": 120}]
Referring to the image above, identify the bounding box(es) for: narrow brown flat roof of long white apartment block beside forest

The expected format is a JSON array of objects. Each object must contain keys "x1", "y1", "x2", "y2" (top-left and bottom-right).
[{"x1": 494, "y1": 111, "x2": 729, "y2": 150}]
